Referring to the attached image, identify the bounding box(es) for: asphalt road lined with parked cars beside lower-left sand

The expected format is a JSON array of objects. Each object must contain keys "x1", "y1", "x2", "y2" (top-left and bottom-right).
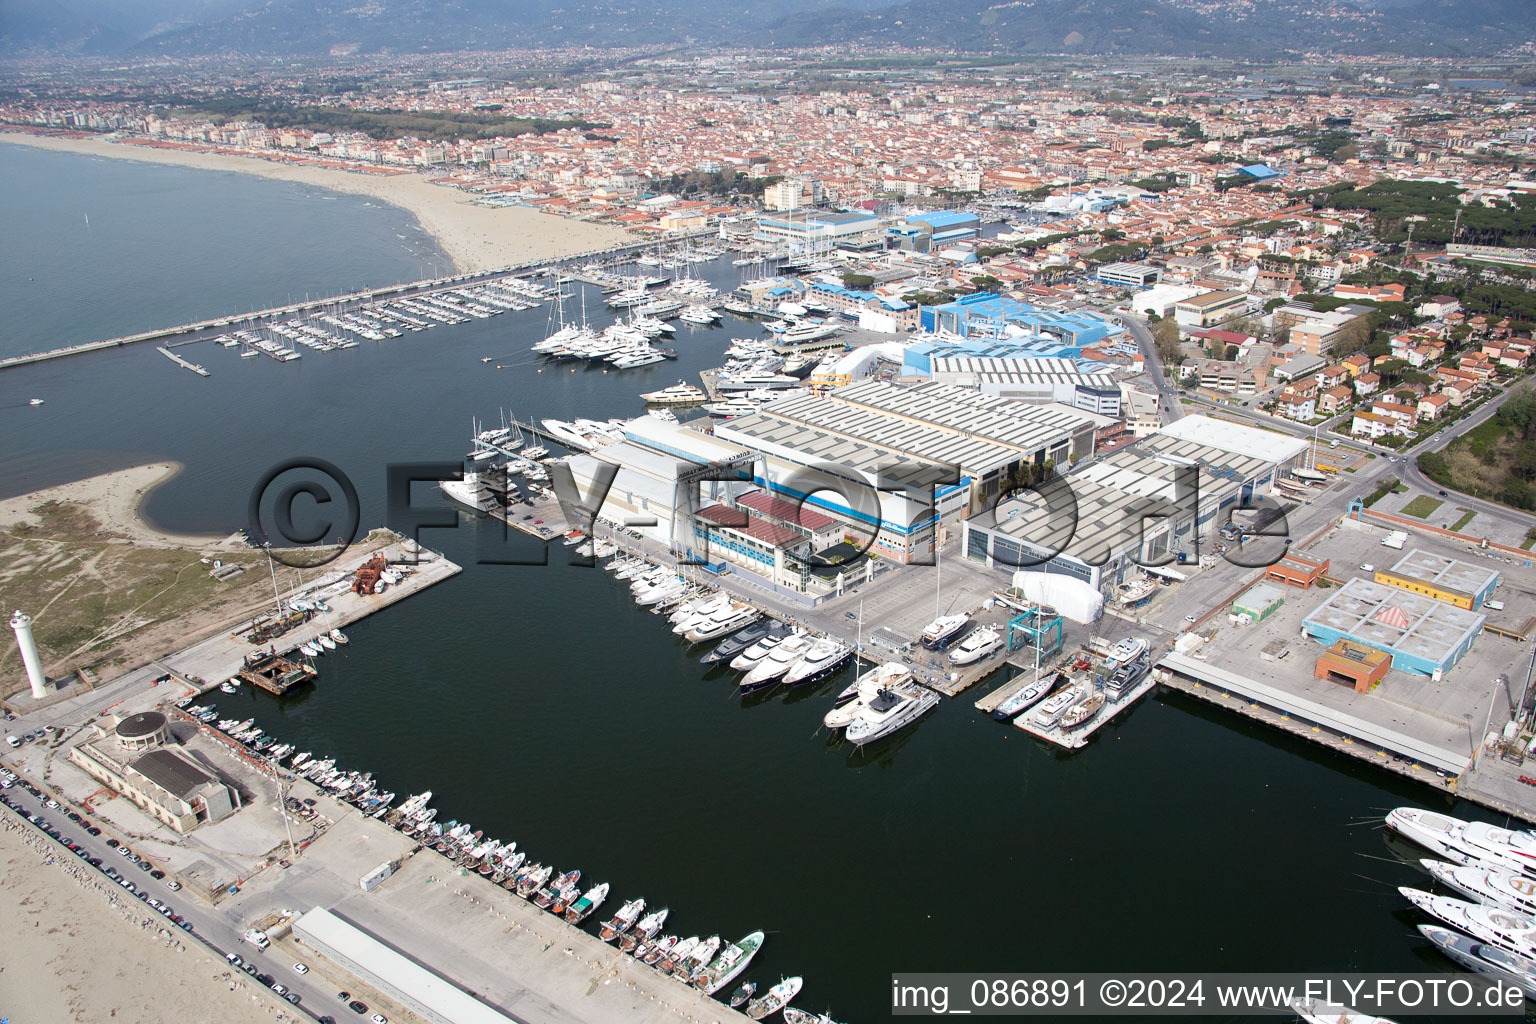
[{"x1": 0, "y1": 780, "x2": 343, "y2": 1021}]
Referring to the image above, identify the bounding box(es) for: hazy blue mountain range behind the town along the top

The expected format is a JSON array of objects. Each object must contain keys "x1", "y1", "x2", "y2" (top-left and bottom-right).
[{"x1": 9, "y1": 0, "x2": 1536, "y2": 58}]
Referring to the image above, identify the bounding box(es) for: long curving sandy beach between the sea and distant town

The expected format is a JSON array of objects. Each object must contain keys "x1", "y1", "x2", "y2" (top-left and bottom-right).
[{"x1": 0, "y1": 132, "x2": 631, "y2": 273}]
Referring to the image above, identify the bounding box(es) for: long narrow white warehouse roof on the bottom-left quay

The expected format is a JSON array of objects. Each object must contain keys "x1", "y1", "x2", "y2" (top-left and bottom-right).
[{"x1": 293, "y1": 907, "x2": 513, "y2": 1024}]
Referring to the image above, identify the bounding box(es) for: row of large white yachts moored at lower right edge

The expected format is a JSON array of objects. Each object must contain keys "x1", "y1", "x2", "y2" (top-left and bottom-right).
[{"x1": 1385, "y1": 808, "x2": 1536, "y2": 1001}]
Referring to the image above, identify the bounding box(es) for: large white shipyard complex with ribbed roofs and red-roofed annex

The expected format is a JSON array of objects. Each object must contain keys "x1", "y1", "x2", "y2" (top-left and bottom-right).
[{"x1": 568, "y1": 381, "x2": 1095, "y2": 599}]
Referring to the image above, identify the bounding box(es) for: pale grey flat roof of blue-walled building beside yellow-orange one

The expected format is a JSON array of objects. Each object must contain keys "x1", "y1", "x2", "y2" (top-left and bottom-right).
[{"x1": 1303, "y1": 577, "x2": 1485, "y2": 663}]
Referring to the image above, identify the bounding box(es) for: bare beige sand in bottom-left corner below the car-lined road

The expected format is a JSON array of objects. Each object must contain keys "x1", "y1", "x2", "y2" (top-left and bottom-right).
[{"x1": 0, "y1": 812, "x2": 288, "y2": 1024}]
